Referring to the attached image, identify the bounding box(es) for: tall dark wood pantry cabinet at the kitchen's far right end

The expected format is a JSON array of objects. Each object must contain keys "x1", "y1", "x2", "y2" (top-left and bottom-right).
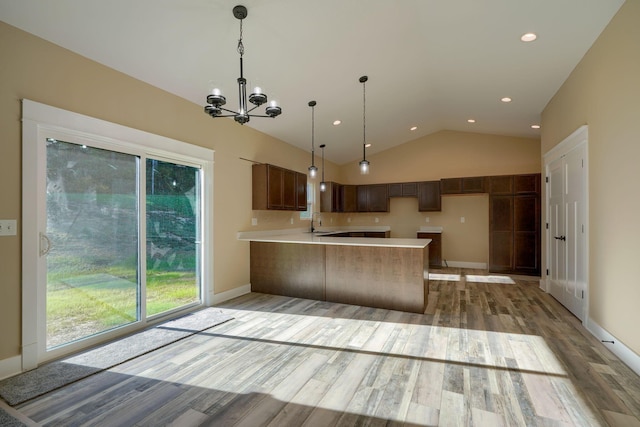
[{"x1": 489, "y1": 174, "x2": 541, "y2": 275}]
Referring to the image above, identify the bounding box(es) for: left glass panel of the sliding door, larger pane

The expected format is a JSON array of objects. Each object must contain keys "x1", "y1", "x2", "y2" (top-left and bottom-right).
[{"x1": 46, "y1": 138, "x2": 141, "y2": 349}]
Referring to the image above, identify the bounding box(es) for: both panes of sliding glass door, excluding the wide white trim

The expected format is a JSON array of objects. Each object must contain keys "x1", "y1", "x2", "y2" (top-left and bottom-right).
[{"x1": 43, "y1": 138, "x2": 201, "y2": 349}]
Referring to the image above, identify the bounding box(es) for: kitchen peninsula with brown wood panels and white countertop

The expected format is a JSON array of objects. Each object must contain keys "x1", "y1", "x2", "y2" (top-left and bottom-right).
[{"x1": 238, "y1": 230, "x2": 431, "y2": 313}]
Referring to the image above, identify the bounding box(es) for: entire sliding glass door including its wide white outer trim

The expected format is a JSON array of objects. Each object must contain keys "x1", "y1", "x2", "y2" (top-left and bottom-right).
[{"x1": 21, "y1": 99, "x2": 214, "y2": 370}]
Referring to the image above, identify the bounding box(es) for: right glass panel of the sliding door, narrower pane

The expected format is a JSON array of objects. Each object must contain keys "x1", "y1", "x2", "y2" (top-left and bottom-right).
[{"x1": 146, "y1": 159, "x2": 201, "y2": 316}]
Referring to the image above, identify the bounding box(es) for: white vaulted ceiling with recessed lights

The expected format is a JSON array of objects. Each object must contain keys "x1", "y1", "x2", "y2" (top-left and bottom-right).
[{"x1": 0, "y1": 0, "x2": 624, "y2": 164}]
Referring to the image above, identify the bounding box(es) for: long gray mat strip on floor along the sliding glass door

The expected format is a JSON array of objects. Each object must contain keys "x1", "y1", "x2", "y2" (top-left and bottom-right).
[{"x1": 0, "y1": 308, "x2": 233, "y2": 406}]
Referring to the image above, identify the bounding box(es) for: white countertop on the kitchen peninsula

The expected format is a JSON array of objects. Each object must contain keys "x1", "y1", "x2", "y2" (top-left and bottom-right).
[{"x1": 238, "y1": 229, "x2": 431, "y2": 249}]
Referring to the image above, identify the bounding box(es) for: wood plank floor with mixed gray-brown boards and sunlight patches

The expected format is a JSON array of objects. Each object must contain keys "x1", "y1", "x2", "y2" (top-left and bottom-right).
[{"x1": 12, "y1": 269, "x2": 640, "y2": 427}]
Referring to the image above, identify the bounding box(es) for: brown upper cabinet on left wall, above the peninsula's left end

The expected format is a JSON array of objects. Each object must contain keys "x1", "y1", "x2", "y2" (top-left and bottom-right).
[{"x1": 252, "y1": 163, "x2": 307, "y2": 211}]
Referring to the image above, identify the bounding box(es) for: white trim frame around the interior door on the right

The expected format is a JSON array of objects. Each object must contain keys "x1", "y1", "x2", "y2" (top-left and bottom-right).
[{"x1": 541, "y1": 125, "x2": 589, "y2": 324}]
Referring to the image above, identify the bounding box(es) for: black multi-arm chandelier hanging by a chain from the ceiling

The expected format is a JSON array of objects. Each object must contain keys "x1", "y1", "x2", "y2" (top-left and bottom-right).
[{"x1": 204, "y1": 5, "x2": 282, "y2": 125}]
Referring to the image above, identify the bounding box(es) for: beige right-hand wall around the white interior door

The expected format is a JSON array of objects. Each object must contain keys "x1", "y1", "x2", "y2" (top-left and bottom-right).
[{"x1": 542, "y1": 0, "x2": 640, "y2": 355}]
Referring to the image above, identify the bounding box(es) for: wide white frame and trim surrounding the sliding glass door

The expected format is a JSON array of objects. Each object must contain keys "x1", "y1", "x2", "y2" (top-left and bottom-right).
[{"x1": 22, "y1": 99, "x2": 214, "y2": 371}]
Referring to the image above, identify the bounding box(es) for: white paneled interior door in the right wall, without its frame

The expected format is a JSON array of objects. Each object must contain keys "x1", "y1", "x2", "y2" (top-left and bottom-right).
[{"x1": 545, "y1": 132, "x2": 588, "y2": 320}]
